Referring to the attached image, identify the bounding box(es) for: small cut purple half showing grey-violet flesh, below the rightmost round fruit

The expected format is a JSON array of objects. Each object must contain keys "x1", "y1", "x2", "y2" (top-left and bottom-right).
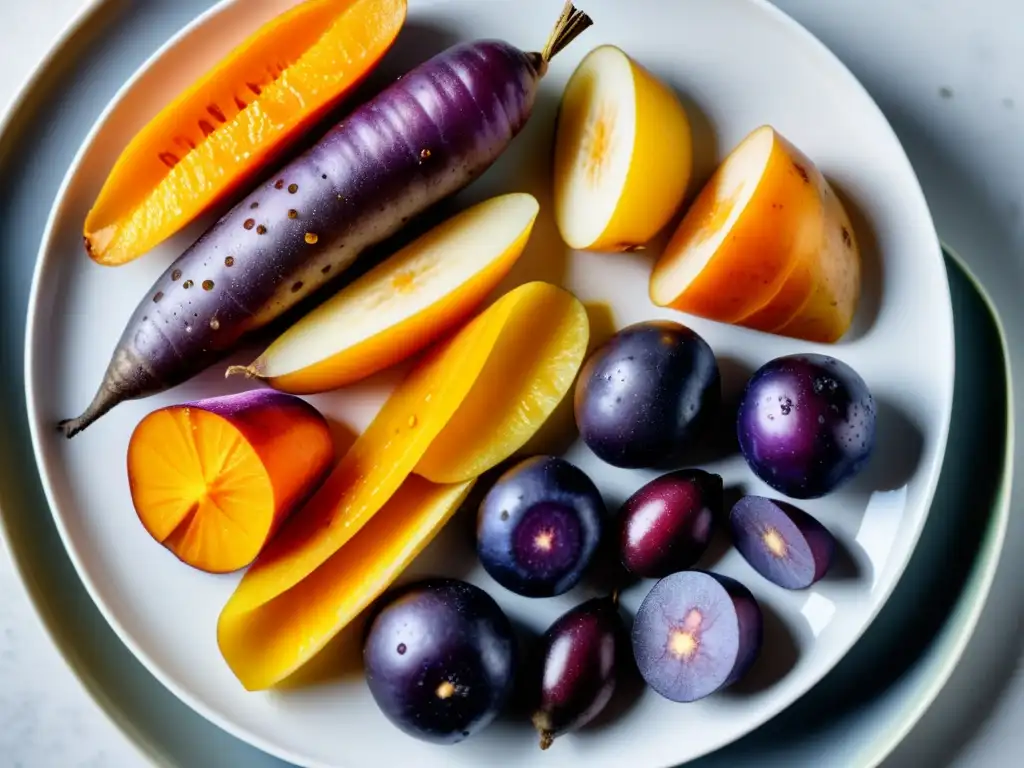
[{"x1": 729, "y1": 496, "x2": 836, "y2": 590}]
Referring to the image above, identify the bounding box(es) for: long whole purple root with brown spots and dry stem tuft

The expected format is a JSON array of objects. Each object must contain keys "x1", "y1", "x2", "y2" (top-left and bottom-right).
[{"x1": 59, "y1": 6, "x2": 591, "y2": 437}]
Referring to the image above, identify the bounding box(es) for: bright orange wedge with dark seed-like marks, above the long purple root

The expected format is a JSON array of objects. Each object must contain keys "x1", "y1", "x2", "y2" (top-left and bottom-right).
[{"x1": 84, "y1": 0, "x2": 406, "y2": 265}]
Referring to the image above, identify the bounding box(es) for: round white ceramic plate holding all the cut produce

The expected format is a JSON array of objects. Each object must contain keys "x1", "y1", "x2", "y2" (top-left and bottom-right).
[{"x1": 27, "y1": 0, "x2": 953, "y2": 768}]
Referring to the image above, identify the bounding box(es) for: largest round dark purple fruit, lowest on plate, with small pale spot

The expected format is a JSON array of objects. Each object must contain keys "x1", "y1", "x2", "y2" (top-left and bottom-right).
[{"x1": 362, "y1": 579, "x2": 517, "y2": 744}]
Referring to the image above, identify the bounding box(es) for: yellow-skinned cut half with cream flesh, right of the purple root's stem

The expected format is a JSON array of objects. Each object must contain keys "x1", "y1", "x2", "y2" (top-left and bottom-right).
[{"x1": 554, "y1": 45, "x2": 693, "y2": 251}]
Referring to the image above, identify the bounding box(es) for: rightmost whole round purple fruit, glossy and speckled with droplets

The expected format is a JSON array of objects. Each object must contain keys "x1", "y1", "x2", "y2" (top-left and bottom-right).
[{"x1": 736, "y1": 353, "x2": 876, "y2": 499}]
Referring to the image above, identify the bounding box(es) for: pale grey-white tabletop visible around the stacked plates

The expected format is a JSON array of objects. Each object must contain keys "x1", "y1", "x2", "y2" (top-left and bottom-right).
[{"x1": 0, "y1": 0, "x2": 1024, "y2": 768}]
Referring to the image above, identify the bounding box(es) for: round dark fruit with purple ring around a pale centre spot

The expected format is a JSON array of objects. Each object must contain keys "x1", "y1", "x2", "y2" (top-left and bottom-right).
[{"x1": 476, "y1": 456, "x2": 605, "y2": 597}]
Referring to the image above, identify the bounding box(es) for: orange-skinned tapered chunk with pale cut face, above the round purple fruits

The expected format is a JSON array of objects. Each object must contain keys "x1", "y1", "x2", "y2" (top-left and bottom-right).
[{"x1": 650, "y1": 126, "x2": 860, "y2": 331}]
